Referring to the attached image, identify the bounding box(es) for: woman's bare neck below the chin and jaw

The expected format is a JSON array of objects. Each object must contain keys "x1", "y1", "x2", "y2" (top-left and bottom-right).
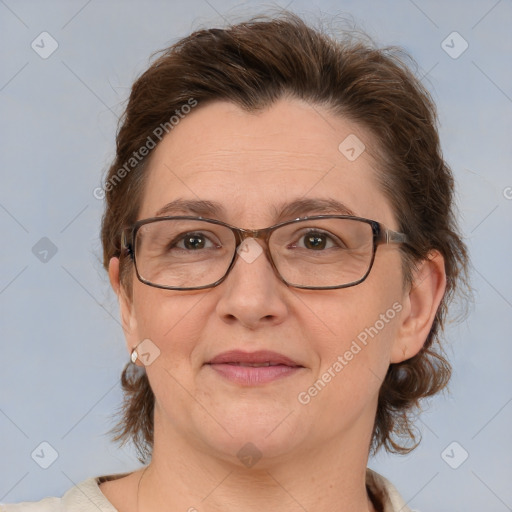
[{"x1": 138, "y1": 422, "x2": 374, "y2": 512}]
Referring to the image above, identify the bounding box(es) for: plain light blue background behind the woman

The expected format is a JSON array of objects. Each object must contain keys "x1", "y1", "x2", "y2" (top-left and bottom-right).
[{"x1": 0, "y1": 0, "x2": 512, "y2": 512}]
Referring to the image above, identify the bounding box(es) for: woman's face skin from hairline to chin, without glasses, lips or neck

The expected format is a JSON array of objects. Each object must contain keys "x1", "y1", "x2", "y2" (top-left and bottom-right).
[{"x1": 113, "y1": 99, "x2": 410, "y2": 461}]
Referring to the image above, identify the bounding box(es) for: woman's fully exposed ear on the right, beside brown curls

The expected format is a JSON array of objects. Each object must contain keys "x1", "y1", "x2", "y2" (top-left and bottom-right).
[{"x1": 390, "y1": 251, "x2": 446, "y2": 363}]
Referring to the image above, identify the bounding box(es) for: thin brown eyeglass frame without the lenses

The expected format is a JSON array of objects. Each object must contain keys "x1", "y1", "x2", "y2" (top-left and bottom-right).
[{"x1": 121, "y1": 215, "x2": 408, "y2": 291}]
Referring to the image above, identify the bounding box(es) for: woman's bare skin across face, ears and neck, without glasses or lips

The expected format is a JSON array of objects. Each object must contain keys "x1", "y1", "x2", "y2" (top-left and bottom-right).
[{"x1": 101, "y1": 98, "x2": 446, "y2": 512}]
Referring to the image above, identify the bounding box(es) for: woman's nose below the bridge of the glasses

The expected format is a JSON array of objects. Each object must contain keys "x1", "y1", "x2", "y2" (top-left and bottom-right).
[{"x1": 216, "y1": 238, "x2": 288, "y2": 329}]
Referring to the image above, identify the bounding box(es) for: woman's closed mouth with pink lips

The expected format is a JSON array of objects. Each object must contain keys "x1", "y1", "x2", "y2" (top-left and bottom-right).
[{"x1": 206, "y1": 350, "x2": 304, "y2": 386}]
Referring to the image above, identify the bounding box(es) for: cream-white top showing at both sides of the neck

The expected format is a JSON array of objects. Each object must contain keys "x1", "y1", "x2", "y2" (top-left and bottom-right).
[{"x1": 0, "y1": 469, "x2": 411, "y2": 512}]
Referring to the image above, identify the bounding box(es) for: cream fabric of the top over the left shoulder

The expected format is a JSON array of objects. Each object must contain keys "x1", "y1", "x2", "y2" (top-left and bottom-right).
[{"x1": 0, "y1": 475, "x2": 124, "y2": 512}]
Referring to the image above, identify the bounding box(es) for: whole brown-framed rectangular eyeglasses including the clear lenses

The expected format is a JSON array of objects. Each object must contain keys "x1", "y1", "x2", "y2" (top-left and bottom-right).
[{"x1": 122, "y1": 215, "x2": 407, "y2": 290}]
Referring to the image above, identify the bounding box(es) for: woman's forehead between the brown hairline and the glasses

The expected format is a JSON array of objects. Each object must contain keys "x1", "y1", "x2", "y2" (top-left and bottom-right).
[{"x1": 139, "y1": 99, "x2": 394, "y2": 228}]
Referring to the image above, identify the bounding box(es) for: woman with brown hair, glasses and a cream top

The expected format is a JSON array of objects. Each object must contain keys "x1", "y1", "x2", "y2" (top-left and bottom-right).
[{"x1": 3, "y1": 9, "x2": 467, "y2": 512}]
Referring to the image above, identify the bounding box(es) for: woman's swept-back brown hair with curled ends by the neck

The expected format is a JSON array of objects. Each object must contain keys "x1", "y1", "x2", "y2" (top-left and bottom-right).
[{"x1": 101, "y1": 12, "x2": 468, "y2": 462}]
